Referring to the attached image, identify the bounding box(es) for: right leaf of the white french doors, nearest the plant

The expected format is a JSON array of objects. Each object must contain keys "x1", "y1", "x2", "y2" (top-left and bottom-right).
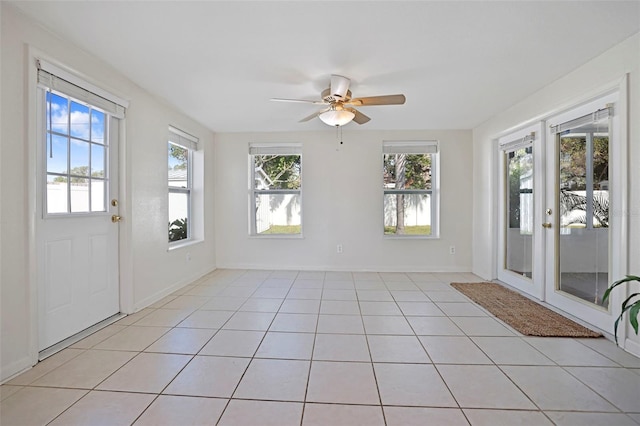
[{"x1": 544, "y1": 94, "x2": 625, "y2": 331}]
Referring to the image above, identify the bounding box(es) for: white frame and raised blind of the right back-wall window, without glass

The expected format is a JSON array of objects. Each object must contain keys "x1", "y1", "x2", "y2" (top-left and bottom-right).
[{"x1": 381, "y1": 140, "x2": 440, "y2": 239}]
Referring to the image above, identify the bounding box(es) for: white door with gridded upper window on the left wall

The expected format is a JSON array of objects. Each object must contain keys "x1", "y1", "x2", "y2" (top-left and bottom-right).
[{"x1": 36, "y1": 88, "x2": 120, "y2": 350}]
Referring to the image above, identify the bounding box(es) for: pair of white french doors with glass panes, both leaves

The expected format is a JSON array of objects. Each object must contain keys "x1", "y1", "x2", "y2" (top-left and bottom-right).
[{"x1": 497, "y1": 92, "x2": 626, "y2": 331}]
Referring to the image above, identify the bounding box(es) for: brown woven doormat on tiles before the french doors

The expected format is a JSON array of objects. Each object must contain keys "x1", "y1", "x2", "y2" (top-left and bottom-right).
[{"x1": 451, "y1": 283, "x2": 602, "y2": 337}]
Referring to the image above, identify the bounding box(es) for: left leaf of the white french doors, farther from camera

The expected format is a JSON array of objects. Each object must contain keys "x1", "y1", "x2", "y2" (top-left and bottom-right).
[{"x1": 498, "y1": 123, "x2": 544, "y2": 299}]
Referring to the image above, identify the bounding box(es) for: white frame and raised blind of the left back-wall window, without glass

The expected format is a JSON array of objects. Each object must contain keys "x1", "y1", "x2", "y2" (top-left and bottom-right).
[{"x1": 248, "y1": 143, "x2": 304, "y2": 238}]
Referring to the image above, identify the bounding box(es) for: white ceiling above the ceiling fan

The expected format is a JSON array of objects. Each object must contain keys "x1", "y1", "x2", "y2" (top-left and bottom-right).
[{"x1": 13, "y1": 0, "x2": 640, "y2": 132}]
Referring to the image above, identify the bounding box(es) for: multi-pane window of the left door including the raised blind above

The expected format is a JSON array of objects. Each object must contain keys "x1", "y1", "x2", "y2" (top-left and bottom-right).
[{"x1": 37, "y1": 60, "x2": 126, "y2": 216}]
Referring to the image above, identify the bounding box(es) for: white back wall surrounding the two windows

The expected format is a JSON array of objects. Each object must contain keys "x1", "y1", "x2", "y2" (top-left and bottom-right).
[{"x1": 215, "y1": 128, "x2": 472, "y2": 271}]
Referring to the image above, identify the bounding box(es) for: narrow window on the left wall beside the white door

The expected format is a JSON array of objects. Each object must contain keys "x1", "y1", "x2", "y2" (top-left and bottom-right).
[{"x1": 167, "y1": 127, "x2": 198, "y2": 243}]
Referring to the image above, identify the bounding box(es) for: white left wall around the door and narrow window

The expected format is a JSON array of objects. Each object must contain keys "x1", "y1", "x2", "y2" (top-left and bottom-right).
[{"x1": 0, "y1": 3, "x2": 215, "y2": 380}]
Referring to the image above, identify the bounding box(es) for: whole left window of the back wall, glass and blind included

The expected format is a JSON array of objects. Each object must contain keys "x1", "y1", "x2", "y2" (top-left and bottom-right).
[{"x1": 249, "y1": 144, "x2": 302, "y2": 235}]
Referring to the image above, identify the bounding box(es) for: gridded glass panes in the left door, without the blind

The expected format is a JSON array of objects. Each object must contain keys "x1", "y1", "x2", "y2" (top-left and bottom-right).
[{"x1": 45, "y1": 89, "x2": 109, "y2": 215}]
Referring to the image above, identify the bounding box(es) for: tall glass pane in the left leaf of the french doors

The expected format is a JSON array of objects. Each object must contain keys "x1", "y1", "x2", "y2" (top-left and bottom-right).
[{"x1": 504, "y1": 147, "x2": 534, "y2": 278}]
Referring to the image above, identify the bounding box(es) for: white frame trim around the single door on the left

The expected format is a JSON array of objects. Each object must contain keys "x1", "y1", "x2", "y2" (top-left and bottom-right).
[{"x1": 24, "y1": 45, "x2": 134, "y2": 368}]
